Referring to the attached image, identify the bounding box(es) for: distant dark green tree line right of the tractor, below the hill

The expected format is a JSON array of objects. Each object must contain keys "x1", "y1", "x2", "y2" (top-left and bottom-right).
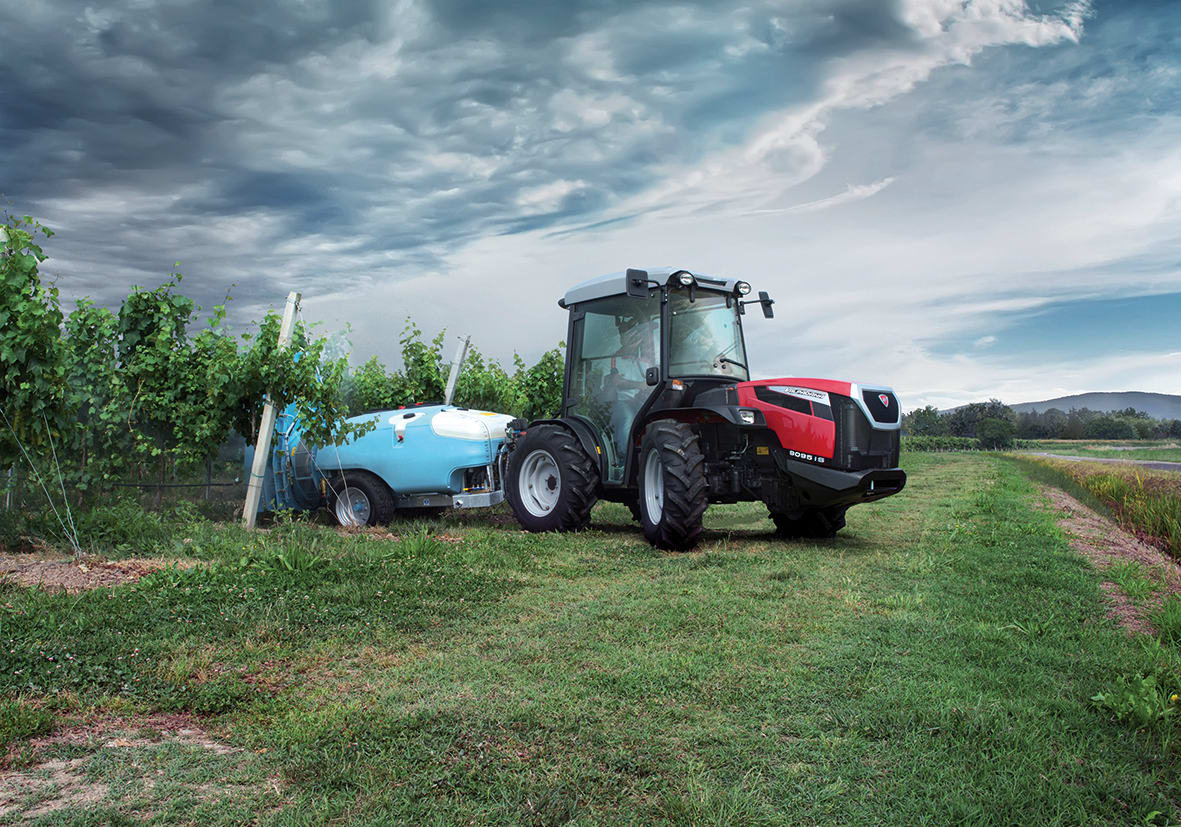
[{"x1": 902, "y1": 399, "x2": 1181, "y2": 447}]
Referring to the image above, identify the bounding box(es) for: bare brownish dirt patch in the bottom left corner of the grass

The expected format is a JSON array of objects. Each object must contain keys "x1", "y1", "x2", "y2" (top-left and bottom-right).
[{"x1": 0, "y1": 715, "x2": 280, "y2": 820}]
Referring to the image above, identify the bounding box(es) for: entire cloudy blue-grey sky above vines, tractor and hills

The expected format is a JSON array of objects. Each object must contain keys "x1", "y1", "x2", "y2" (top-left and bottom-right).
[{"x1": 0, "y1": 0, "x2": 1181, "y2": 409}]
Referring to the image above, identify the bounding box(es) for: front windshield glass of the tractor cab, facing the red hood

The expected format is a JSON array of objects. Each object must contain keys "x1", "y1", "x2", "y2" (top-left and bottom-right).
[{"x1": 668, "y1": 291, "x2": 750, "y2": 382}]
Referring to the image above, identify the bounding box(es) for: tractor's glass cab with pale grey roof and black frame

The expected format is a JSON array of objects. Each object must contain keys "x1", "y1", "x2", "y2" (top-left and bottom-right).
[{"x1": 559, "y1": 268, "x2": 771, "y2": 486}]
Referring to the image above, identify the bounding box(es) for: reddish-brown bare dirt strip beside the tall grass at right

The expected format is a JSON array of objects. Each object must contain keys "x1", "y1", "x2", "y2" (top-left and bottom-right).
[{"x1": 1038, "y1": 486, "x2": 1181, "y2": 633}]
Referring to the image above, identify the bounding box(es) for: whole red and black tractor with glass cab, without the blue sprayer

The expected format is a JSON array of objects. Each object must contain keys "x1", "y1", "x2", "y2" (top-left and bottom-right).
[{"x1": 504, "y1": 269, "x2": 906, "y2": 549}]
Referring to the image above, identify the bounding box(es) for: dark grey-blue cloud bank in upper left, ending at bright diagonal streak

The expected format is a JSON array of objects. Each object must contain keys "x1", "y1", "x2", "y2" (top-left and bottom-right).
[{"x1": 0, "y1": 0, "x2": 1124, "y2": 352}]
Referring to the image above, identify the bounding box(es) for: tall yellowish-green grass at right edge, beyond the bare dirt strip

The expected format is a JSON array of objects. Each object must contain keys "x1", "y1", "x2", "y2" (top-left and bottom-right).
[{"x1": 1014, "y1": 456, "x2": 1181, "y2": 559}]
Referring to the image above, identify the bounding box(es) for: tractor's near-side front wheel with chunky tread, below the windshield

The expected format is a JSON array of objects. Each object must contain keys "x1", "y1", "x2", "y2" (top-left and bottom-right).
[{"x1": 639, "y1": 419, "x2": 709, "y2": 551}]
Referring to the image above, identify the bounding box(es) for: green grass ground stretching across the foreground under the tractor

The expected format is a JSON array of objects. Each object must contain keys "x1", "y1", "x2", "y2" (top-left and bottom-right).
[{"x1": 0, "y1": 454, "x2": 1181, "y2": 825}]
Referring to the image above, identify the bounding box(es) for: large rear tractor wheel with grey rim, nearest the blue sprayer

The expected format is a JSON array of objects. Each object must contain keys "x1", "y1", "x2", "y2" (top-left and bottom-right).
[{"x1": 504, "y1": 425, "x2": 599, "y2": 532}]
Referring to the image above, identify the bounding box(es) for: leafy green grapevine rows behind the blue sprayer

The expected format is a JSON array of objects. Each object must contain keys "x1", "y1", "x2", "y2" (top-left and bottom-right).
[{"x1": 0, "y1": 216, "x2": 563, "y2": 491}]
